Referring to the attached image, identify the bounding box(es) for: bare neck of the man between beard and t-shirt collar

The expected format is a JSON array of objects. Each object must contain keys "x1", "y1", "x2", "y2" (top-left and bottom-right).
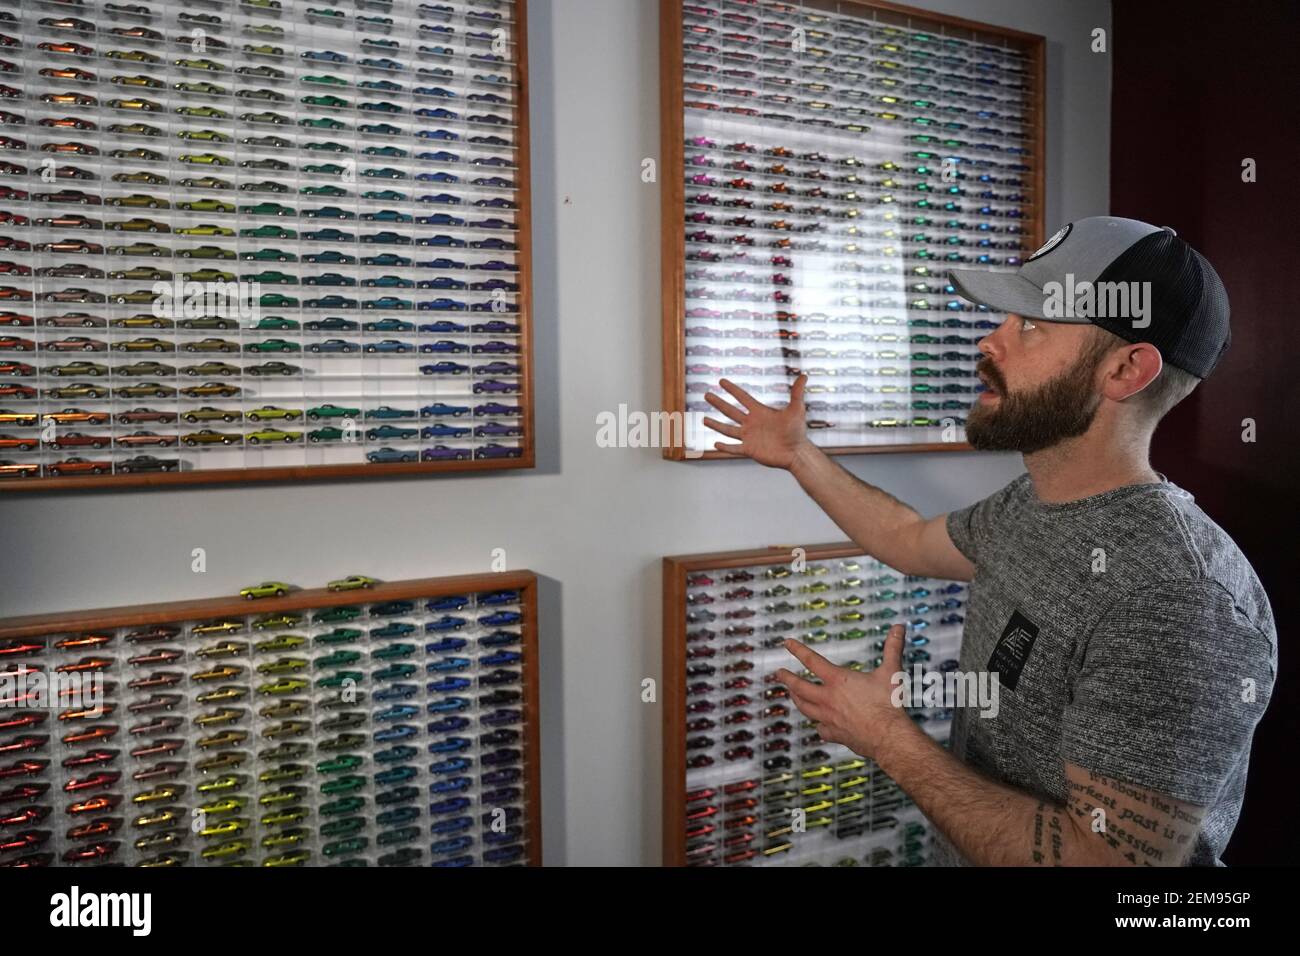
[{"x1": 1024, "y1": 431, "x2": 1161, "y2": 505}]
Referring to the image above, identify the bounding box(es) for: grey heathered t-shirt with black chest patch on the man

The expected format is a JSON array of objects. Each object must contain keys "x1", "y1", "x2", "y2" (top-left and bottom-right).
[{"x1": 931, "y1": 473, "x2": 1277, "y2": 866}]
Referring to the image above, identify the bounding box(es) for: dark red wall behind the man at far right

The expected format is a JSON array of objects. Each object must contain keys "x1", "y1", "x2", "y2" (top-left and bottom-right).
[{"x1": 1110, "y1": 0, "x2": 1300, "y2": 865}]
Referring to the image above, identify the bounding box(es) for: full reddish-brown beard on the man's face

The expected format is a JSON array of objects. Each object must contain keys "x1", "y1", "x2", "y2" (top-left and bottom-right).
[{"x1": 966, "y1": 352, "x2": 1104, "y2": 454}]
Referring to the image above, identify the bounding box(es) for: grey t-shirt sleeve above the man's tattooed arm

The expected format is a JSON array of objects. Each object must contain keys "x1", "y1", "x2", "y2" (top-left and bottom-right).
[{"x1": 1062, "y1": 580, "x2": 1275, "y2": 806}]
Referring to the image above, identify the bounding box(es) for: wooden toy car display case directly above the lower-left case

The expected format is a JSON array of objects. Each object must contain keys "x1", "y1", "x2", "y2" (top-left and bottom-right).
[{"x1": 0, "y1": 0, "x2": 534, "y2": 489}]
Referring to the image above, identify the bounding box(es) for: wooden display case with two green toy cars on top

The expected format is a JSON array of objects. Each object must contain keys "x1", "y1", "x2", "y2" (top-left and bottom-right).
[{"x1": 0, "y1": 571, "x2": 542, "y2": 866}]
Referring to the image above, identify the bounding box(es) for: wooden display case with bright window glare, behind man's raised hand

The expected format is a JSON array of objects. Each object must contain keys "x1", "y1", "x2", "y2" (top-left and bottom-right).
[{"x1": 659, "y1": 0, "x2": 1045, "y2": 459}]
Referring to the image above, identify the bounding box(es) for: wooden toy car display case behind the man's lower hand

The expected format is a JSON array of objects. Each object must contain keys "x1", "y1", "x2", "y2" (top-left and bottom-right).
[{"x1": 663, "y1": 542, "x2": 966, "y2": 866}]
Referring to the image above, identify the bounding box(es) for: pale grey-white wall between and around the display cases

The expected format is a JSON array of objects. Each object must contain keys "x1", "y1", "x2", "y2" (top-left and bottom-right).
[{"x1": 0, "y1": 0, "x2": 1110, "y2": 865}]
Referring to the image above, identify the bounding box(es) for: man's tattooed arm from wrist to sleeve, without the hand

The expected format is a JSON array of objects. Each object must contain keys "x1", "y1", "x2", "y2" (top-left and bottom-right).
[{"x1": 876, "y1": 721, "x2": 1203, "y2": 866}]
